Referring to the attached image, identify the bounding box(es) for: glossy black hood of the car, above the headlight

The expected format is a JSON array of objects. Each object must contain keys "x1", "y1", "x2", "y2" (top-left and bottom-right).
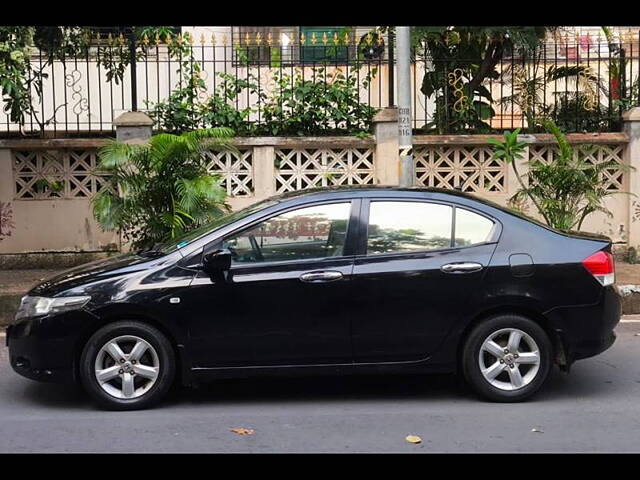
[{"x1": 28, "y1": 253, "x2": 155, "y2": 296}]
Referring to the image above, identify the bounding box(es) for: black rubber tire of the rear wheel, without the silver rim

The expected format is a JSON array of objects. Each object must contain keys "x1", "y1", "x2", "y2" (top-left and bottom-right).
[{"x1": 462, "y1": 314, "x2": 553, "y2": 402}]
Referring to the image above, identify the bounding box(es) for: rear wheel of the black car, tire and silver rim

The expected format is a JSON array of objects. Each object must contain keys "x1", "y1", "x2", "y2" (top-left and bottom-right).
[{"x1": 462, "y1": 314, "x2": 553, "y2": 402}]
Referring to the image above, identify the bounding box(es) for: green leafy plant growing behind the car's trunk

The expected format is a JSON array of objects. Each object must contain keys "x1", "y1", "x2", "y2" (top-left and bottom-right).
[{"x1": 491, "y1": 119, "x2": 624, "y2": 231}]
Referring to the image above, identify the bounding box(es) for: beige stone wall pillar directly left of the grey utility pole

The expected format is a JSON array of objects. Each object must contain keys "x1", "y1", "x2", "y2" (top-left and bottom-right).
[{"x1": 373, "y1": 108, "x2": 400, "y2": 185}]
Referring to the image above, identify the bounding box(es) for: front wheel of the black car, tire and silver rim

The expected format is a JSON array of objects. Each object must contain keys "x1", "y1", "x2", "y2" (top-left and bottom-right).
[{"x1": 79, "y1": 321, "x2": 176, "y2": 410}]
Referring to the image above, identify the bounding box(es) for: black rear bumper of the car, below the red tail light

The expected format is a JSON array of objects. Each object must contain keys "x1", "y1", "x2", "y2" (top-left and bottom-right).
[{"x1": 545, "y1": 286, "x2": 621, "y2": 366}]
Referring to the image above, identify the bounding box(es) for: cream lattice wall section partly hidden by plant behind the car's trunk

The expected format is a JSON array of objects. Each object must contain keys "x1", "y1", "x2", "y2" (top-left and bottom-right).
[{"x1": 529, "y1": 144, "x2": 625, "y2": 192}]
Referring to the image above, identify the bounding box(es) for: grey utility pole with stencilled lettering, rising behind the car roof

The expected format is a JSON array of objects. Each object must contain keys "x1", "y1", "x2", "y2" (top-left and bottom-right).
[{"x1": 396, "y1": 27, "x2": 415, "y2": 187}]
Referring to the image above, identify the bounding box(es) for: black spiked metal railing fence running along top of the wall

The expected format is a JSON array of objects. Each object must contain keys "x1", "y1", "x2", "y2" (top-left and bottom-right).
[{"x1": 0, "y1": 29, "x2": 640, "y2": 137}]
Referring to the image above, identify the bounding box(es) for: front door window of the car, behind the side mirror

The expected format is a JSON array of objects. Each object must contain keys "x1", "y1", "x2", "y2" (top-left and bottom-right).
[{"x1": 223, "y1": 203, "x2": 351, "y2": 264}]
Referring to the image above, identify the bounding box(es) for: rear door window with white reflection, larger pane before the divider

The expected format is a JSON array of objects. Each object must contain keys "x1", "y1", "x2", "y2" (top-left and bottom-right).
[{"x1": 367, "y1": 202, "x2": 453, "y2": 255}]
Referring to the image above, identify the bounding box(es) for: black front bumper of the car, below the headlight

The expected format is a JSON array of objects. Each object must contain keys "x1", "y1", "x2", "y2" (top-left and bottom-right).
[{"x1": 7, "y1": 310, "x2": 98, "y2": 383}]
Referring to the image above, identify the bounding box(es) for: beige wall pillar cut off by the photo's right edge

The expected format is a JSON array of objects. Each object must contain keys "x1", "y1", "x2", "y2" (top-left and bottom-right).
[{"x1": 622, "y1": 107, "x2": 640, "y2": 249}]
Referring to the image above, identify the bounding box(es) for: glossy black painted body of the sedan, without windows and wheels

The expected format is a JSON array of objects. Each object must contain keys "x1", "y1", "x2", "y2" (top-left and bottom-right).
[{"x1": 7, "y1": 187, "x2": 620, "y2": 384}]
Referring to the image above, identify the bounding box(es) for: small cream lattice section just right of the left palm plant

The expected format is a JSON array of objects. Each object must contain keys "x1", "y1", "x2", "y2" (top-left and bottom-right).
[{"x1": 205, "y1": 149, "x2": 254, "y2": 197}]
